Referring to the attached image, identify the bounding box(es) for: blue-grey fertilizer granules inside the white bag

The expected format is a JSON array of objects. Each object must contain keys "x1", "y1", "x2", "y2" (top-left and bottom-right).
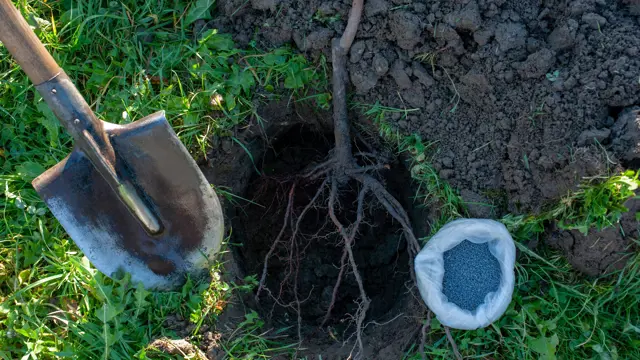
[{"x1": 442, "y1": 240, "x2": 502, "y2": 311}]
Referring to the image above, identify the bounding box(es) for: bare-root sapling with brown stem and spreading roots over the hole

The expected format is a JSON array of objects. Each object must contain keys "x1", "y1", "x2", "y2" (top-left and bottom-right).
[{"x1": 256, "y1": 0, "x2": 430, "y2": 359}]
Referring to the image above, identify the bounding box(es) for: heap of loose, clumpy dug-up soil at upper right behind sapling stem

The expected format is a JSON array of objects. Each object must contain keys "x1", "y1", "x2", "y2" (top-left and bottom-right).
[{"x1": 208, "y1": 0, "x2": 640, "y2": 274}]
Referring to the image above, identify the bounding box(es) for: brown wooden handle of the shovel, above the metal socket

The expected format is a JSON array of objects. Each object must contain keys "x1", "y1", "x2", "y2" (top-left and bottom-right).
[{"x1": 0, "y1": 0, "x2": 61, "y2": 85}]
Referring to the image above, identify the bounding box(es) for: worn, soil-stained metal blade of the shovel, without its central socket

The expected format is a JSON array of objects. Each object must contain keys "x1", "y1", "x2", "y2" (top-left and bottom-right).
[{"x1": 33, "y1": 112, "x2": 224, "y2": 289}]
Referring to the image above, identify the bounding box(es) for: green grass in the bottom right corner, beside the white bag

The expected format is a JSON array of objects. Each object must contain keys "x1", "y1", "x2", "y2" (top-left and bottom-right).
[{"x1": 407, "y1": 246, "x2": 640, "y2": 359}]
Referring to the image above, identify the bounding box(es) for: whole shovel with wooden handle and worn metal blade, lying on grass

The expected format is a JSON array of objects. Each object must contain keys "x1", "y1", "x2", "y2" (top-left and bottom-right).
[{"x1": 0, "y1": 0, "x2": 224, "y2": 289}]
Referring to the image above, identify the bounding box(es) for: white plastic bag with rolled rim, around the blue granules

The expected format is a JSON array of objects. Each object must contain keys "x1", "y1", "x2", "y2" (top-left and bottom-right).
[{"x1": 415, "y1": 219, "x2": 516, "y2": 330}]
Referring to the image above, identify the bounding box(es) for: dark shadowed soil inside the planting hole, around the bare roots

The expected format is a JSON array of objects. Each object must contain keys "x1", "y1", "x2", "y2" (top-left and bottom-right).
[{"x1": 203, "y1": 102, "x2": 428, "y2": 359}]
